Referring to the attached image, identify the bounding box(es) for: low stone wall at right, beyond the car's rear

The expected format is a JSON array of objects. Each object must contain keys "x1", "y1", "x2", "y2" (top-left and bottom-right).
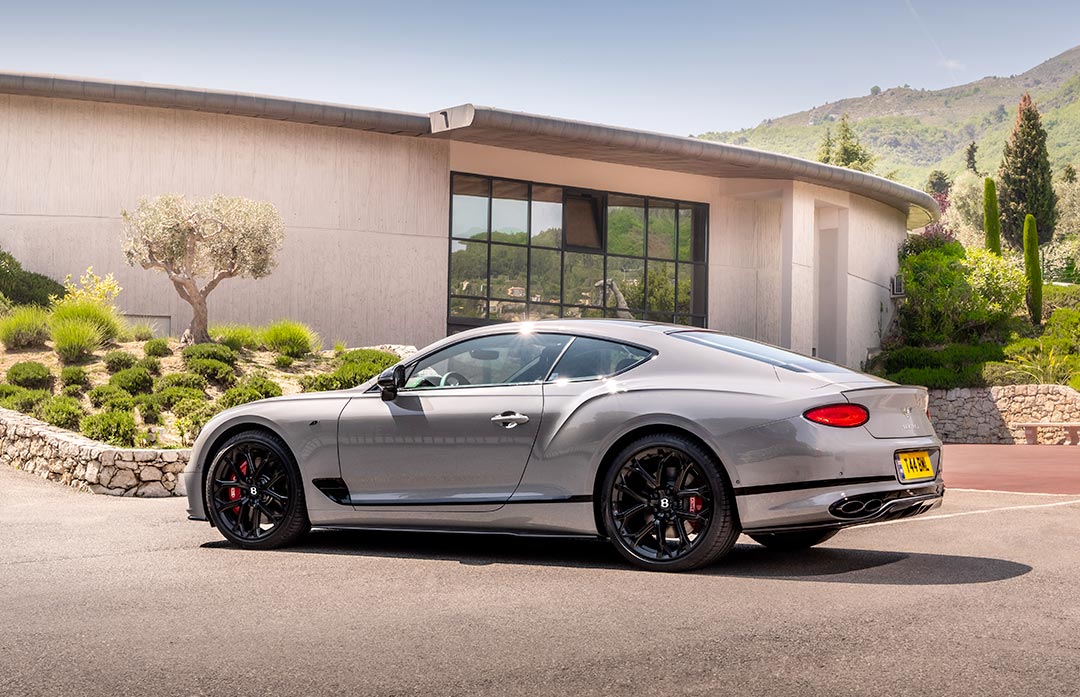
[{"x1": 930, "y1": 385, "x2": 1080, "y2": 444}]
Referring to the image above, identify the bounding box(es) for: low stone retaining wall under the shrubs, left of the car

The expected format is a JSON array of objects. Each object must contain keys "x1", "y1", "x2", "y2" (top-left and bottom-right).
[{"x1": 0, "y1": 408, "x2": 191, "y2": 497}]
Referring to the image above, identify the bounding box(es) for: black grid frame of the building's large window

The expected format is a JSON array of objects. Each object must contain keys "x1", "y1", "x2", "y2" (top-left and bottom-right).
[{"x1": 446, "y1": 171, "x2": 710, "y2": 334}]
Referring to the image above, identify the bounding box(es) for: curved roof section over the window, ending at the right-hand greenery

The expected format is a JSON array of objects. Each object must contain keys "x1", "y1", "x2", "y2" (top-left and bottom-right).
[{"x1": 430, "y1": 104, "x2": 941, "y2": 229}]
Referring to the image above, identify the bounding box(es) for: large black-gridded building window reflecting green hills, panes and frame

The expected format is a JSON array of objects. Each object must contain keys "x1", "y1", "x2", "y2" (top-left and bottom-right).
[{"x1": 448, "y1": 173, "x2": 708, "y2": 331}]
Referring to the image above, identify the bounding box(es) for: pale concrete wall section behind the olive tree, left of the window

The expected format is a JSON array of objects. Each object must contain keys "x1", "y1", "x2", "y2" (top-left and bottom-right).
[{"x1": 0, "y1": 95, "x2": 449, "y2": 345}]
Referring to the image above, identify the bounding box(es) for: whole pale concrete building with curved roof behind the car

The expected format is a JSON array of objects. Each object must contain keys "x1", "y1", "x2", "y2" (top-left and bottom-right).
[{"x1": 0, "y1": 73, "x2": 939, "y2": 366}]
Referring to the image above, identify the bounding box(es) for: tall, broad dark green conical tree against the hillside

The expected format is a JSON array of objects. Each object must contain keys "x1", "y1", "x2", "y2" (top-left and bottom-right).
[{"x1": 998, "y1": 94, "x2": 1057, "y2": 246}]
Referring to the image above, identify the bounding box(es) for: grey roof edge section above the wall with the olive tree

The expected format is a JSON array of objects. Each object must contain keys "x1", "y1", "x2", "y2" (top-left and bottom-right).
[{"x1": 0, "y1": 72, "x2": 431, "y2": 136}]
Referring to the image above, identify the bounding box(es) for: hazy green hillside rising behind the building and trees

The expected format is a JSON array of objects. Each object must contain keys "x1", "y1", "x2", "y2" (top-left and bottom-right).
[{"x1": 698, "y1": 46, "x2": 1080, "y2": 187}]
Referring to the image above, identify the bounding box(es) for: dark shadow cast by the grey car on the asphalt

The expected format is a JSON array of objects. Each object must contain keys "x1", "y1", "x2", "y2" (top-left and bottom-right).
[{"x1": 203, "y1": 530, "x2": 1031, "y2": 586}]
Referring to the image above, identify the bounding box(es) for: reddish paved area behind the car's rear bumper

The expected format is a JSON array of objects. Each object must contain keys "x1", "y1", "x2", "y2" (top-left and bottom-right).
[{"x1": 943, "y1": 444, "x2": 1080, "y2": 495}]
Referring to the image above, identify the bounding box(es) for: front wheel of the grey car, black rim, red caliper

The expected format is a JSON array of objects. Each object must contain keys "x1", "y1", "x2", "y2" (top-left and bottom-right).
[{"x1": 203, "y1": 430, "x2": 311, "y2": 549}]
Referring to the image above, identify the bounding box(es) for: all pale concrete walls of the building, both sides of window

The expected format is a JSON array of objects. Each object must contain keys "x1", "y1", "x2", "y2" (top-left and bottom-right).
[{"x1": 0, "y1": 95, "x2": 905, "y2": 366}]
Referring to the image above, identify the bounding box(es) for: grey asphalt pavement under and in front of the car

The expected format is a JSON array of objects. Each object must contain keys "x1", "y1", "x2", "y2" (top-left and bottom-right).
[{"x1": 0, "y1": 468, "x2": 1080, "y2": 697}]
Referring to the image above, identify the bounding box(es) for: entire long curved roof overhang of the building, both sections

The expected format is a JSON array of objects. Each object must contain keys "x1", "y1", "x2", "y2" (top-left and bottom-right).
[{"x1": 0, "y1": 72, "x2": 941, "y2": 229}]
